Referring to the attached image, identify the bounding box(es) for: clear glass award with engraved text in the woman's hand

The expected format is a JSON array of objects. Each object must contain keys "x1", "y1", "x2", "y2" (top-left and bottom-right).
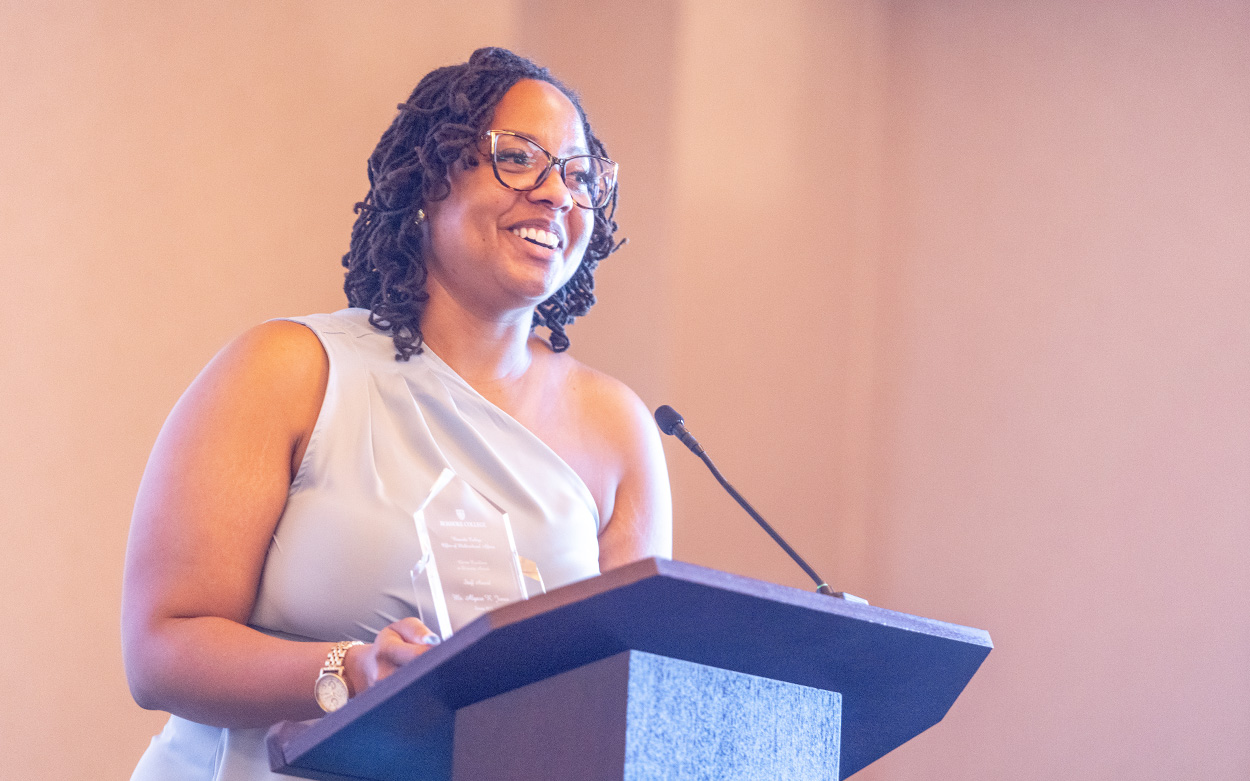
[{"x1": 413, "y1": 469, "x2": 538, "y2": 640}]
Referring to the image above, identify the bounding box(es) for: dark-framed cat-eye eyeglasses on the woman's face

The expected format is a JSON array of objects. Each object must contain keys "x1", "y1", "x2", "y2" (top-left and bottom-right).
[{"x1": 485, "y1": 130, "x2": 619, "y2": 209}]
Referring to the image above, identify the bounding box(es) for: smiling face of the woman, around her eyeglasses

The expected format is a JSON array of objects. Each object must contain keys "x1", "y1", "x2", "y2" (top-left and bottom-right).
[{"x1": 425, "y1": 80, "x2": 595, "y2": 316}]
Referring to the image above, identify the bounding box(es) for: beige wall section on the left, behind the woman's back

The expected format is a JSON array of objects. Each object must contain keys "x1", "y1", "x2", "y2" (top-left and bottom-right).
[{"x1": 0, "y1": 1, "x2": 515, "y2": 780}]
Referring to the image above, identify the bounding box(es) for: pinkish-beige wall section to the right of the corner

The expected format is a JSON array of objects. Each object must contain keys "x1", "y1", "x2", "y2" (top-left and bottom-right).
[{"x1": 870, "y1": 1, "x2": 1250, "y2": 781}]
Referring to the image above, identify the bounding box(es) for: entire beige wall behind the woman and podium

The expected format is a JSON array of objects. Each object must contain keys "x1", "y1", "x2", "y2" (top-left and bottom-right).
[{"x1": 0, "y1": 0, "x2": 1250, "y2": 781}]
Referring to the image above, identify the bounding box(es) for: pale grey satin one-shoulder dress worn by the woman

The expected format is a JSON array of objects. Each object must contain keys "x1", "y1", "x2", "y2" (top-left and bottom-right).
[{"x1": 131, "y1": 309, "x2": 599, "y2": 781}]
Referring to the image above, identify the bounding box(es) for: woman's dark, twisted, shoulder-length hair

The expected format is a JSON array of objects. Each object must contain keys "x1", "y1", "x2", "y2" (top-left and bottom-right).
[{"x1": 343, "y1": 49, "x2": 624, "y2": 361}]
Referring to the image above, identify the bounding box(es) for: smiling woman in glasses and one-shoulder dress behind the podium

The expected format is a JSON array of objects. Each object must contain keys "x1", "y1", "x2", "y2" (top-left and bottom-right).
[{"x1": 123, "y1": 49, "x2": 671, "y2": 779}]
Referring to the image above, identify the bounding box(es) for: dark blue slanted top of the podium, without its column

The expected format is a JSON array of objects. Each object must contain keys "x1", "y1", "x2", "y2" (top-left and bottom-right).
[{"x1": 269, "y1": 559, "x2": 993, "y2": 781}]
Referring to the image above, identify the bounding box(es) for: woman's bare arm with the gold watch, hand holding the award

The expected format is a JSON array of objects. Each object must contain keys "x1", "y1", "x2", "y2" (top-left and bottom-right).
[{"x1": 123, "y1": 322, "x2": 435, "y2": 727}]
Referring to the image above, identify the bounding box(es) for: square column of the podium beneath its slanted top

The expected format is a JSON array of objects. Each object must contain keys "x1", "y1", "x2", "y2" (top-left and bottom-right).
[{"x1": 451, "y1": 651, "x2": 841, "y2": 781}]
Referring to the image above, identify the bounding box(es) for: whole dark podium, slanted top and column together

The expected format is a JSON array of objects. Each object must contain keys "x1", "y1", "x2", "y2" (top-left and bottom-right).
[{"x1": 268, "y1": 559, "x2": 993, "y2": 781}]
